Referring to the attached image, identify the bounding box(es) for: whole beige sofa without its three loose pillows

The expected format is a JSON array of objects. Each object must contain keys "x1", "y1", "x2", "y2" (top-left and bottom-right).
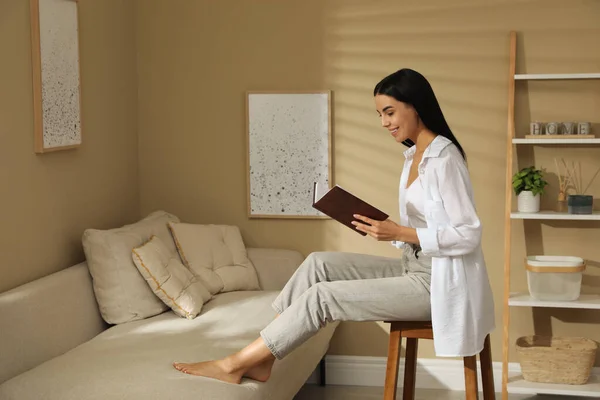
[{"x1": 0, "y1": 211, "x2": 337, "y2": 400}]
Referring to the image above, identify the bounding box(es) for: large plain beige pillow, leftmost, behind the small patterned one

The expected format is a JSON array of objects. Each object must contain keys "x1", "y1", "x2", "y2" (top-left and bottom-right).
[{"x1": 82, "y1": 211, "x2": 179, "y2": 324}]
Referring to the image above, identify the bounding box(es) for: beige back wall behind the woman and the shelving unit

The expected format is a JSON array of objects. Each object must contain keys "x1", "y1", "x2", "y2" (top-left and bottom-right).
[{"x1": 142, "y1": 0, "x2": 600, "y2": 365}]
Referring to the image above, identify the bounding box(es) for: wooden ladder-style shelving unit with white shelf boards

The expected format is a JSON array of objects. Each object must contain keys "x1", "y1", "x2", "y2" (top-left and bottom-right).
[{"x1": 502, "y1": 32, "x2": 600, "y2": 400}]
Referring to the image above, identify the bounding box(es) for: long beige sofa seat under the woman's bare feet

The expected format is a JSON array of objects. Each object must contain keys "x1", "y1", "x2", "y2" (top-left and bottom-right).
[{"x1": 0, "y1": 291, "x2": 337, "y2": 400}]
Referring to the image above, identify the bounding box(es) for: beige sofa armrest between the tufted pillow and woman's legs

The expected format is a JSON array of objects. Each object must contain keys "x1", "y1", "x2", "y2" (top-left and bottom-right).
[{"x1": 247, "y1": 248, "x2": 304, "y2": 290}]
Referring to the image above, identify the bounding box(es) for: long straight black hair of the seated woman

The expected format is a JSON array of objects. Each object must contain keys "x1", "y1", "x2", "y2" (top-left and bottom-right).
[{"x1": 373, "y1": 68, "x2": 466, "y2": 159}]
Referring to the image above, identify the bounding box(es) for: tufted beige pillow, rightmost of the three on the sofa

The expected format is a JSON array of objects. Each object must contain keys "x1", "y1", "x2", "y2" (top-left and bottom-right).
[{"x1": 169, "y1": 222, "x2": 260, "y2": 295}]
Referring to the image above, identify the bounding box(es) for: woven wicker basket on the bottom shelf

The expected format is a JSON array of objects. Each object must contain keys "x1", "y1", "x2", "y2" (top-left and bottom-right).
[{"x1": 516, "y1": 335, "x2": 598, "y2": 385}]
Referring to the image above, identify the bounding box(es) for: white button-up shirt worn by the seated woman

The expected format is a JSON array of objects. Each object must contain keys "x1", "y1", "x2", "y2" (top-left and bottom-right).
[{"x1": 393, "y1": 136, "x2": 495, "y2": 357}]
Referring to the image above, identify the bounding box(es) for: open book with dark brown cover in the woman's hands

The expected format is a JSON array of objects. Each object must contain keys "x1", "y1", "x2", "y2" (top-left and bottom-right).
[{"x1": 313, "y1": 182, "x2": 389, "y2": 236}]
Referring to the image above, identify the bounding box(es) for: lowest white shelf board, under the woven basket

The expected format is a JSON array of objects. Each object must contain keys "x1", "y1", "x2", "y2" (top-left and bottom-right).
[{"x1": 507, "y1": 375, "x2": 600, "y2": 398}]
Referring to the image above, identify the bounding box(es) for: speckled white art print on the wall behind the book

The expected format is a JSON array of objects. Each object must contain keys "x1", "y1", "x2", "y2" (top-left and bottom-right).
[{"x1": 248, "y1": 93, "x2": 330, "y2": 217}]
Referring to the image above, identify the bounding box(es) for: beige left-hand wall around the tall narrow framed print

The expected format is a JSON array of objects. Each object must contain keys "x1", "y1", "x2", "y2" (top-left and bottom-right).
[{"x1": 0, "y1": 0, "x2": 139, "y2": 292}]
